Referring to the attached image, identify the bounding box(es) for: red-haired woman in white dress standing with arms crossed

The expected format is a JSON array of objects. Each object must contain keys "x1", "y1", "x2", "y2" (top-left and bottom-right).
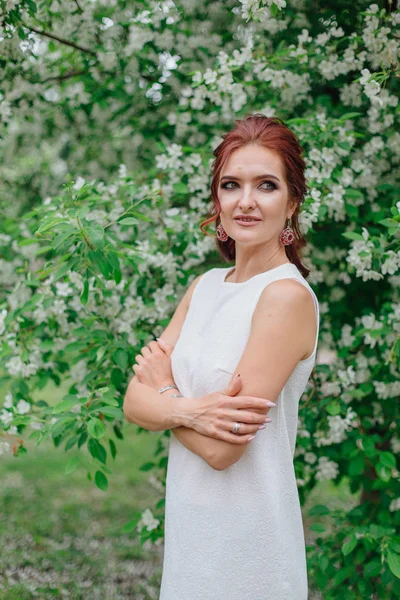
[{"x1": 124, "y1": 114, "x2": 319, "y2": 600}]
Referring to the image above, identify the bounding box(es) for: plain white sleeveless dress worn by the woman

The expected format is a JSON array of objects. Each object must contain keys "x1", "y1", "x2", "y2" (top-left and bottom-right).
[{"x1": 159, "y1": 263, "x2": 319, "y2": 600}]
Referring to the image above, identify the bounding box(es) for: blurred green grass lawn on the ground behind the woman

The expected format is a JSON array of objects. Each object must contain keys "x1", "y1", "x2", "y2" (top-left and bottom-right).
[{"x1": 0, "y1": 382, "x2": 356, "y2": 600}]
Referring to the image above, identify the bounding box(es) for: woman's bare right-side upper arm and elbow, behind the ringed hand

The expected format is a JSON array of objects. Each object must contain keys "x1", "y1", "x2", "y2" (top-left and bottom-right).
[{"x1": 126, "y1": 279, "x2": 316, "y2": 470}]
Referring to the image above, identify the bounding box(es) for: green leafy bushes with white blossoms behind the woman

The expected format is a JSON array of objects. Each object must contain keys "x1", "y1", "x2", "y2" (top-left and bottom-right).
[{"x1": 0, "y1": 0, "x2": 400, "y2": 600}]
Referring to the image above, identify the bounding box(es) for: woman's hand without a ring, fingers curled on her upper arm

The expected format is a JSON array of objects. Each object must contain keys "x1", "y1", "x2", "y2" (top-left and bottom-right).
[{"x1": 132, "y1": 338, "x2": 175, "y2": 390}]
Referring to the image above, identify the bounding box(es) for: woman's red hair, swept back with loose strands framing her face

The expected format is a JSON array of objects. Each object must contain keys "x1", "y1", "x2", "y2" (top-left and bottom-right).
[{"x1": 200, "y1": 113, "x2": 310, "y2": 277}]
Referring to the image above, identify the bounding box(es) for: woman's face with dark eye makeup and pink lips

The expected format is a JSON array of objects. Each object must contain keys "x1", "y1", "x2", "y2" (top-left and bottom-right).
[{"x1": 218, "y1": 144, "x2": 295, "y2": 245}]
